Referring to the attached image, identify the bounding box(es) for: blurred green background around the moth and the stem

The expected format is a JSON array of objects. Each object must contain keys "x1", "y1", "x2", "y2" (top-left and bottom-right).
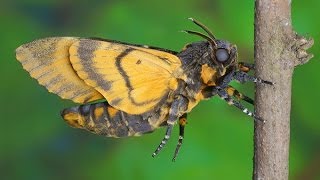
[{"x1": 0, "y1": 0, "x2": 320, "y2": 179}]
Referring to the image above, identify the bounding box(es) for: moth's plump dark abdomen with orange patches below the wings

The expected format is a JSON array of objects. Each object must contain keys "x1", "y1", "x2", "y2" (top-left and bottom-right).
[{"x1": 61, "y1": 102, "x2": 154, "y2": 137}]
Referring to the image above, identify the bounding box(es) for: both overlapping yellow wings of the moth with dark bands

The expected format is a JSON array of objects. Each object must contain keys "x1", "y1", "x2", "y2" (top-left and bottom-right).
[{"x1": 16, "y1": 37, "x2": 181, "y2": 114}]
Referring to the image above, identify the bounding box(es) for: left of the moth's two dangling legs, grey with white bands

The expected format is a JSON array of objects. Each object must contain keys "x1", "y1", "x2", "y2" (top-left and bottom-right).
[{"x1": 152, "y1": 95, "x2": 188, "y2": 157}]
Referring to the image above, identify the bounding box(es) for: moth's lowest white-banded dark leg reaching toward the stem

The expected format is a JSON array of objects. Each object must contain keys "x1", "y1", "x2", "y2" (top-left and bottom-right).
[{"x1": 216, "y1": 87, "x2": 264, "y2": 122}]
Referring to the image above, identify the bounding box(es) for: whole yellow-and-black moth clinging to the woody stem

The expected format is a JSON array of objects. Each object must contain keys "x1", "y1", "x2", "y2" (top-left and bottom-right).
[{"x1": 16, "y1": 18, "x2": 272, "y2": 161}]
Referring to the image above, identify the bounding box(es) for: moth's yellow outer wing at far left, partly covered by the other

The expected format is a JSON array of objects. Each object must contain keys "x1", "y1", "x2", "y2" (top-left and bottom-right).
[{"x1": 16, "y1": 37, "x2": 103, "y2": 103}]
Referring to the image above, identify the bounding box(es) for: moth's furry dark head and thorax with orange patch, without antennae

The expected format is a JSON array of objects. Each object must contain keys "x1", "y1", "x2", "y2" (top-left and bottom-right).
[{"x1": 177, "y1": 40, "x2": 237, "y2": 111}]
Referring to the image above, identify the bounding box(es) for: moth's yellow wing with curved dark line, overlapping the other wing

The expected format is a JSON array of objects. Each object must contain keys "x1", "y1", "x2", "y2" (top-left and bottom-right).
[{"x1": 70, "y1": 39, "x2": 181, "y2": 114}]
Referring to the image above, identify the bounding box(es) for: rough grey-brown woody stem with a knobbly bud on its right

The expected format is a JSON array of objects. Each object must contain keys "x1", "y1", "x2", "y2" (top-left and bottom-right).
[{"x1": 253, "y1": 0, "x2": 313, "y2": 180}]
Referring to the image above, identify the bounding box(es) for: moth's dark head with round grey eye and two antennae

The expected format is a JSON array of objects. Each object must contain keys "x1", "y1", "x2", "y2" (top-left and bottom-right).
[{"x1": 185, "y1": 18, "x2": 237, "y2": 76}]
